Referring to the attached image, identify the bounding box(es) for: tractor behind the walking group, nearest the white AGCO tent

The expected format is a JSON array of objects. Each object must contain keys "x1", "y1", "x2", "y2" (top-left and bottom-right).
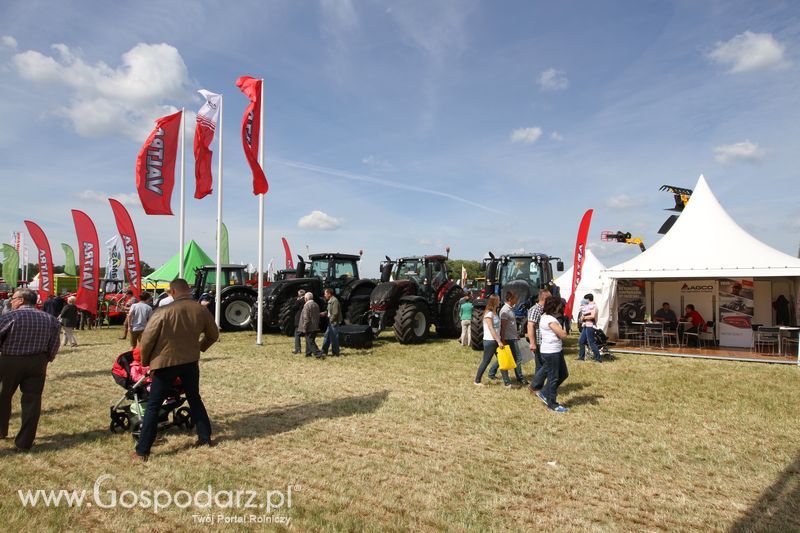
[{"x1": 470, "y1": 252, "x2": 564, "y2": 350}]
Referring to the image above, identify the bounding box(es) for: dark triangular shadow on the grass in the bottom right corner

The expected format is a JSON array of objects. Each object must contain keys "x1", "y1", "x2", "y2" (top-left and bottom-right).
[{"x1": 730, "y1": 450, "x2": 800, "y2": 533}]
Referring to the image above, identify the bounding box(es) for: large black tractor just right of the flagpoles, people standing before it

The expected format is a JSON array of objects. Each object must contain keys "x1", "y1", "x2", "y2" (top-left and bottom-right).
[{"x1": 253, "y1": 253, "x2": 375, "y2": 335}]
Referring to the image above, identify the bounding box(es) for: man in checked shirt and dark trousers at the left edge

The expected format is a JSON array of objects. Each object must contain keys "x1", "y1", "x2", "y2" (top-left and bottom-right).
[{"x1": 0, "y1": 289, "x2": 61, "y2": 451}]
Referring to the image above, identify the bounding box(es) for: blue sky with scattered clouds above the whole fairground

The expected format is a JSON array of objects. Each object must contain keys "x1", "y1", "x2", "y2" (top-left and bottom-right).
[{"x1": 0, "y1": 0, "x2": 800, "y2": 274}]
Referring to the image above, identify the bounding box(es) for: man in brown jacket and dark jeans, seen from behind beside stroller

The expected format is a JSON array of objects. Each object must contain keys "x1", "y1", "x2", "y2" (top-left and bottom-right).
[{"x1": 132, "y1": 278, "x2": 219, "y2": 461}]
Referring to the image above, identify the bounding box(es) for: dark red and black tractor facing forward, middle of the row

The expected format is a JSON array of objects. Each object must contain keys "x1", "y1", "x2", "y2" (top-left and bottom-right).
[{"x1": 369, "y1": 255, "x2": 464, "y2": 344}]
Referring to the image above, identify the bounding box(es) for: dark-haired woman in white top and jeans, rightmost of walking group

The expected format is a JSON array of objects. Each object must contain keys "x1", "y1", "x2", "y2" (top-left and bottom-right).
[{"x1": 531, "y1": 296, "x2": 569, "y2": 413}]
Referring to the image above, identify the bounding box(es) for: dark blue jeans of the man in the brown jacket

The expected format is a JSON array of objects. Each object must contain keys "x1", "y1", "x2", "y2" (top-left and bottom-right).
[{"x1": 136, "y1": 362, "x2": 211, "y2": 456}]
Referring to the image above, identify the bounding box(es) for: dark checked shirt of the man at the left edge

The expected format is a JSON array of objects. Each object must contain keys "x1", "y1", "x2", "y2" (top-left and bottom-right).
[{"x1": 0, "y1": 306, "x2": 61, "y2": 361}]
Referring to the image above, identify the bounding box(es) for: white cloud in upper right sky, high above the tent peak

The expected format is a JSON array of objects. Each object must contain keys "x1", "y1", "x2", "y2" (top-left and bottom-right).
[{"x1": 708, "y1": 31, "x2": 789, "y2": 73}]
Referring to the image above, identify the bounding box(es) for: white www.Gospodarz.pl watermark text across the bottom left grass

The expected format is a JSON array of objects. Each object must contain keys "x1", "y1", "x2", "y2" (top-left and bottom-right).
[{"x1": 17, "y1": 474, "x2": 299, "y2": 516}]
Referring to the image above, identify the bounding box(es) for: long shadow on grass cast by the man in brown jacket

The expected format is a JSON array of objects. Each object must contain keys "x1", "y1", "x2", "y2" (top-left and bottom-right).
[{"x1": 218, "y1": 390, "x2": 389, "y2": 440}]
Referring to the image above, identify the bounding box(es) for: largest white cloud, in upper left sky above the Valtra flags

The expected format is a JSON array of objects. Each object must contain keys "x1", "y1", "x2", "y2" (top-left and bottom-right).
[{"x1": 12, "y1": 43, "x2": 192, "y2": 140}]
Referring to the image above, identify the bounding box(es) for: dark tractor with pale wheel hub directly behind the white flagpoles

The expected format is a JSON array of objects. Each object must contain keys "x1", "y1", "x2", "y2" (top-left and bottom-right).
[{"x1": 192, "y1": 265, "x2": 258, "y2": 331}]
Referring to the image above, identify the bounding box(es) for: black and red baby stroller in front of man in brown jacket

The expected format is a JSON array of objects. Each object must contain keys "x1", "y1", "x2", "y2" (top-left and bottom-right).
[{"x1": 109, "y1": 348, "x2": 194, "y2": 441}]
